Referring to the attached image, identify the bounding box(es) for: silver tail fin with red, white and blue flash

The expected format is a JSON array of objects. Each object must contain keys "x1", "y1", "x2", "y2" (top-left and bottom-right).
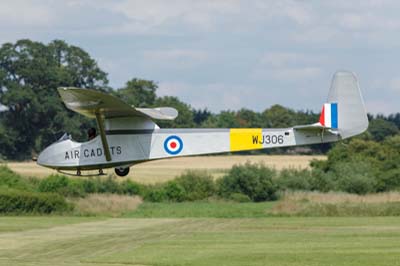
[{"x1": 319, "y1": 71, "x2": 368, "y2": 138}]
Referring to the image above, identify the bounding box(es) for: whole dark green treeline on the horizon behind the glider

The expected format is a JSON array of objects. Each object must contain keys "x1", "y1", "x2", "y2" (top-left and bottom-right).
[{"x1": 0, "y1": 40, "x2": 400, "y2": 160}]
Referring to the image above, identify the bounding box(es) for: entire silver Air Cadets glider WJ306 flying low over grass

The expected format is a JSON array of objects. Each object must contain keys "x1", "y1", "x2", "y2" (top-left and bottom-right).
[{"x1": 37, "y1": 71, "x2": 368, "y2": 176}]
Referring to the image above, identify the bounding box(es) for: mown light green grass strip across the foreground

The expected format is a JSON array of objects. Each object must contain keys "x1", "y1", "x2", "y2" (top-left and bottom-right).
[{"x1": 0, "y1": 217, "x2": 400, "y2": 266}]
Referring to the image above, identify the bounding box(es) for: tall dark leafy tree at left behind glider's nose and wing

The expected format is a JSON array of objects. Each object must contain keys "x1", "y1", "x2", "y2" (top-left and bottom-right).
[{"x1": 0, "y1": 40, "x2": 108, "y2": 159}]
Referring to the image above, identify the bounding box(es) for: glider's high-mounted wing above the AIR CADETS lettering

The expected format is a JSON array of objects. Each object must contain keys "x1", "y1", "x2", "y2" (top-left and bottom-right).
[{"x1": 58, "y1": 87, "x2": 178, "y2": 120}]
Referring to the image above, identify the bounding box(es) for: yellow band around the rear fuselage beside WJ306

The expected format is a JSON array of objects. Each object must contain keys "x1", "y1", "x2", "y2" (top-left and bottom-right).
[{"x1": 229, "y1": 128, "x2": 262, "y2": 151}]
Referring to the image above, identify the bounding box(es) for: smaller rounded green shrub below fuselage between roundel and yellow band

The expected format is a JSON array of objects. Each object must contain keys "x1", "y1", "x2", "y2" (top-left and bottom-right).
[{"x1": 175, "y1": 171, "x2": 216, "y2": 201}]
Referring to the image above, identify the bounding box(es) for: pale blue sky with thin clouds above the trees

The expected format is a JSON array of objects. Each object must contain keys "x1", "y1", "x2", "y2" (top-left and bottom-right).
[{"x1": 0, "y1": 0, "x2": 400, "y2": 114}]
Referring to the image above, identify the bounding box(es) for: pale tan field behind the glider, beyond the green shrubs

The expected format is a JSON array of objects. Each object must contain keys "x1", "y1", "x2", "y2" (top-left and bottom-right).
[{"x1": 7, "y1": 155, "x2": 325, "y2": 183}]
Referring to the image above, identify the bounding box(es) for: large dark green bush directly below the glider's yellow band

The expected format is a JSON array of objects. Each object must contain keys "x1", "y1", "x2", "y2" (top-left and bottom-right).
[{"x1": 218, "y1": 162, "x2": 278, "y2": 202}]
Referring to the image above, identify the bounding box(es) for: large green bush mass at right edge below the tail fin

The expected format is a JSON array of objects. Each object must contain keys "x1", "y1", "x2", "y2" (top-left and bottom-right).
[{"x1": 311, "y1": 135, "x2": 400, "y2": 194}]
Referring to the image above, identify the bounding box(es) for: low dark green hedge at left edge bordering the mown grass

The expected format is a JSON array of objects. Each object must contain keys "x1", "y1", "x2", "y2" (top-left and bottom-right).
[{"x1": 0, "y1": 190, "x2": 72, "y2": 214}]
